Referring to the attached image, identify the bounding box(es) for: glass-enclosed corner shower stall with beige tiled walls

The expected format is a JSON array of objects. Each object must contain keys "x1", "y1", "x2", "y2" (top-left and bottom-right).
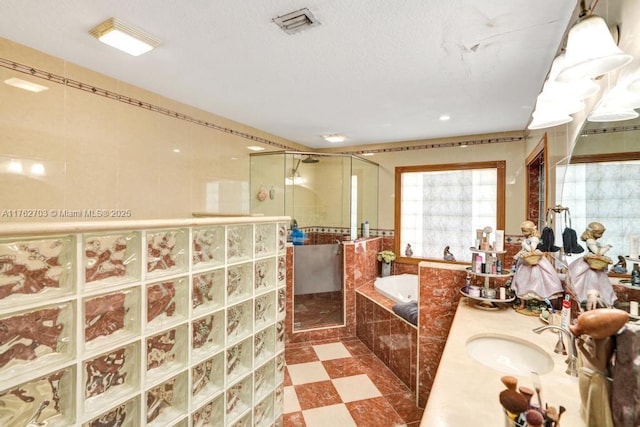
[{"x1": 250, "y1": 151, "x2": 378, "y2": 330}]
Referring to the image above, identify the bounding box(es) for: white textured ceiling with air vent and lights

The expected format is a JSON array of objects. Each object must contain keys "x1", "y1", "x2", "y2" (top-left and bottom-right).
[{"x1": 0, "y1": 0, "x2": 577, "y2": 148}]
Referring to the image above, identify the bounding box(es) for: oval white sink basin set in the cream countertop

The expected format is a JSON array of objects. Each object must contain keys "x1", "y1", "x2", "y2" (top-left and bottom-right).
[{"x1": 466, "y1": 334, "x2": 553, "y2": 375}]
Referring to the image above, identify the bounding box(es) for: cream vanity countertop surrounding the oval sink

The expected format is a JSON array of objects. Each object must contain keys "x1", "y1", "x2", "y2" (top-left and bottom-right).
[{"x1": 420, "y1": 298, "x2": 585, "y2": 427}]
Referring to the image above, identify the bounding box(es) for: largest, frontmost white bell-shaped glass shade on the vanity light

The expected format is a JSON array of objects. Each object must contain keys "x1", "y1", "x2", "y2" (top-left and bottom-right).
[{"x1": 557, "y1": 15, "x2": 633, "y2": 82}]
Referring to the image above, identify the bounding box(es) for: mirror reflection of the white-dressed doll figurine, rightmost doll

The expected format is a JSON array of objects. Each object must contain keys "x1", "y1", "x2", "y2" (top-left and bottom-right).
[{"x1": 569, "y1": 222, "x2": 618, "y2": 307}]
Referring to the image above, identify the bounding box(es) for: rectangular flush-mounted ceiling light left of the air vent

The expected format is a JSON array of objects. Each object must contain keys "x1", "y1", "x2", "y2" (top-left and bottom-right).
[{"x1": 89, "y1": 18, "x2": 160, "y2": 56}]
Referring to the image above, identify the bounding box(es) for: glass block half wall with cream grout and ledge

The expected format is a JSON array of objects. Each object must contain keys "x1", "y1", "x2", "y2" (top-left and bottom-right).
[{"x1": 0, "y1": 217, "x2": 289, "y2": 427}]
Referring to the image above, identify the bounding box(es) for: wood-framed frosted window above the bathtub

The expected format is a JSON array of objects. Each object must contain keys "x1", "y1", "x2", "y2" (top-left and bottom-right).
[{"x1": 395, "y1": 161, "x2": 505, "y2": 262}]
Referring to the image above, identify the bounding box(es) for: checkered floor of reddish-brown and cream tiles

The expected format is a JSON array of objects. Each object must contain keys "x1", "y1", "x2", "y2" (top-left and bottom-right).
[{"x1": 284, "y1": 339, "x2": 422, "y2": 427}]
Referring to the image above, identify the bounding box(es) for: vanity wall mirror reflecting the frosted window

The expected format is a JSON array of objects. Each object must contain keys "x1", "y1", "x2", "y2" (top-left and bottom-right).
[{"x1": 556, "y1": 110, "x2": 640, "y2": 275}]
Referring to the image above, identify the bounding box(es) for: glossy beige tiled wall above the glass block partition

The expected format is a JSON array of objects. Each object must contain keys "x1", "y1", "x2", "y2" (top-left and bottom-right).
[{"x1": 0, "y1": 38, "x2": 304, "y2": 221}]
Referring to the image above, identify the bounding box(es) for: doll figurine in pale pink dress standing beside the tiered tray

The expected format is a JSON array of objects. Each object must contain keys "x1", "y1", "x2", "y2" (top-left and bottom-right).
[{"x1": 512, "y1": 221, "x2": 563, "y2": 308}]
